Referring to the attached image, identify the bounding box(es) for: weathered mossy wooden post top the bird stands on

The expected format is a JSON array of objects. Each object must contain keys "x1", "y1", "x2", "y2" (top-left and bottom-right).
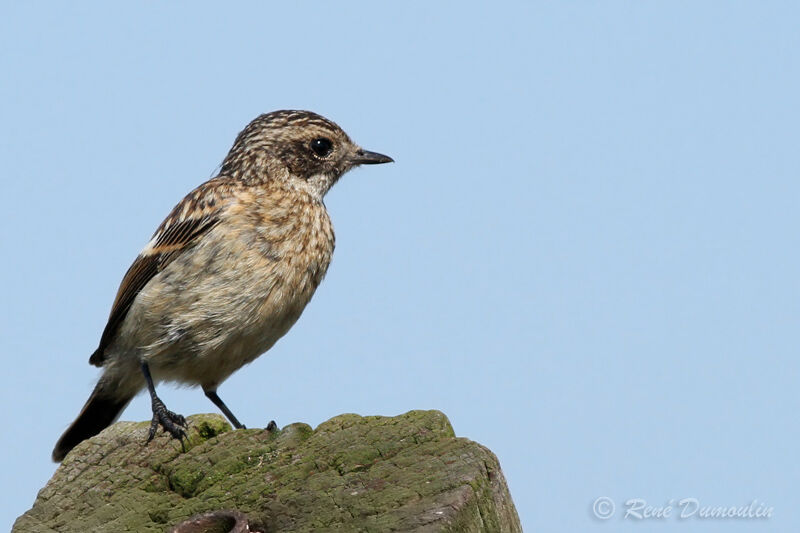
[{"x1": 14, "y1": 411, "x2": 520, "y2": 532}]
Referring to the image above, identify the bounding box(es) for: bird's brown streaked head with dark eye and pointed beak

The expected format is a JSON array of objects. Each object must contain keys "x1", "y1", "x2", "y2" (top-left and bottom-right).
[{"x1": 221, "y1": 111, "x2": 393, "y2": 198}]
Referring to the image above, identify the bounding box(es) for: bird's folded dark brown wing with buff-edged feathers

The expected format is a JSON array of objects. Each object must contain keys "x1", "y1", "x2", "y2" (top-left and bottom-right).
[{"x1": 89, "y1": 177, "x2": 233, "y2": 366}]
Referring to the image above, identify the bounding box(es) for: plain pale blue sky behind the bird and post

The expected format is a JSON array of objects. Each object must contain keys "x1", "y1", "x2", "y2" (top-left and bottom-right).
[{"x1": 0, "y1": 1, "x2": 800, "y2": 531}]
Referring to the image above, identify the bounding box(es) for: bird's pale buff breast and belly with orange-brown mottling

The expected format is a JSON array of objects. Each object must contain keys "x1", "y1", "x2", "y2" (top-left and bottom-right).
[{"x1": 126, "y1": 188, "x2": 334, "y2": 385}]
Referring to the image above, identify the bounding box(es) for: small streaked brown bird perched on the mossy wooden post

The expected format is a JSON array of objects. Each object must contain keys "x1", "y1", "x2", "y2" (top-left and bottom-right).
[{"x1": 52, "y1": 110, "x2": 394, "y2": 462}]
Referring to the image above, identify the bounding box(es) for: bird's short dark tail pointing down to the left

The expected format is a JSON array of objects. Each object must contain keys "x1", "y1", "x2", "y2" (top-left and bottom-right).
[{"x1": 53, "y1": 380, "x2": 136, "y2": 463}]
